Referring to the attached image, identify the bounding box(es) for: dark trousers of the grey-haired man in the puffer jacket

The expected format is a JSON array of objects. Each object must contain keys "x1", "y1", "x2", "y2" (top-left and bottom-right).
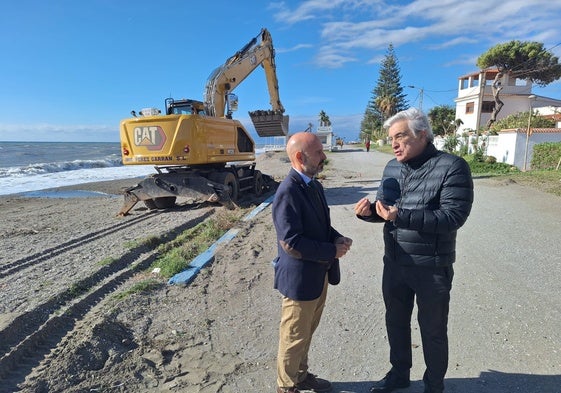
[{"x1": 382, "y1": 263, "x2": 454, "y2": 392}]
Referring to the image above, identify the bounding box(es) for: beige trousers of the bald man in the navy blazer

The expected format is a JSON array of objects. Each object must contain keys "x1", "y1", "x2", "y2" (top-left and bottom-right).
[{"x1": 277, "y1": 276, "x2": 328, "y2": 388}]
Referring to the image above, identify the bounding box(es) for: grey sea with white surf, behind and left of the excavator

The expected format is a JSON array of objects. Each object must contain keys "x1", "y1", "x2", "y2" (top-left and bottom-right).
[{"x1": 0, "y1": 141, "x2": 270, "y2": 195}]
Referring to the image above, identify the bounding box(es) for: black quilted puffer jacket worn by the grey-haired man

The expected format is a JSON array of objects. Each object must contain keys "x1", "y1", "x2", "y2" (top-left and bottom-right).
[{"x1": 359, "y1": 143, "x2": 473, "y2": 267}]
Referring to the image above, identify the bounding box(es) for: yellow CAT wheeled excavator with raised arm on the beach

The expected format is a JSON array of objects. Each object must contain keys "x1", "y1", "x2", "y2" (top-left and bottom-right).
[{"x1": 118, "y1": 29, "x2": 289, "y2": 216}]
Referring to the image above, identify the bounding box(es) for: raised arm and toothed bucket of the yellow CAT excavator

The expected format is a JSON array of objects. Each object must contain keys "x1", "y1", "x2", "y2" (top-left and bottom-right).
[{"x1": 204, "y1": 29, "x2": 288, "y2": 136}]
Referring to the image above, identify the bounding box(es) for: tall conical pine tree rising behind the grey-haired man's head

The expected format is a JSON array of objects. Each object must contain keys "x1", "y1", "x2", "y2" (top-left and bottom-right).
[{"x1": 360, "y1": 44, "x2": 407, "y2": 140}]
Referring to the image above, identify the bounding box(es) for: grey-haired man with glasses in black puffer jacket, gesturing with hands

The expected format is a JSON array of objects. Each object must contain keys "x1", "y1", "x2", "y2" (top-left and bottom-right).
[{"x1": 355, "y1": 108, "x2": 473, "y2": 393}]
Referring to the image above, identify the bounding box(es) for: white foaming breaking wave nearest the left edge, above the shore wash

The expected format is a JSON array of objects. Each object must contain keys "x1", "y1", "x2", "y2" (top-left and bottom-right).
[{"x1": 0, "y1": 157, "x2": 123, "y2": 178}]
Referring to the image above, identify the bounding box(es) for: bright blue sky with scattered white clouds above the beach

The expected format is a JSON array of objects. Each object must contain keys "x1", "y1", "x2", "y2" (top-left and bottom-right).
[{"x1": 0, "y1": 0, "x2": 561, "y2": 143}]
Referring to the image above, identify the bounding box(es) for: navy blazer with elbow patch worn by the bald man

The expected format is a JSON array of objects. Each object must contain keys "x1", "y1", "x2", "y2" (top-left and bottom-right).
[{"x1": 273, "y1": 169, "x2": 341, "y2": 301}]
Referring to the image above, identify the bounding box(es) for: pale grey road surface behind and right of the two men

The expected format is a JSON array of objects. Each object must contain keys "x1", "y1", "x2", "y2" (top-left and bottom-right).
[{"x1": 294, "y1": 150, "x2": 561, "y2": 393}]
